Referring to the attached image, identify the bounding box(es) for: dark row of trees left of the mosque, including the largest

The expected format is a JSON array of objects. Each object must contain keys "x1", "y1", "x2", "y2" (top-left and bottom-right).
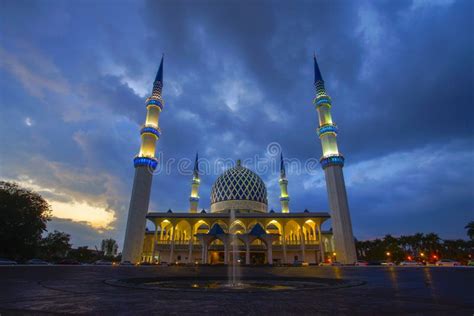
[{"x1": 0, "y1": 181, "x2": 117, "y2": 262}]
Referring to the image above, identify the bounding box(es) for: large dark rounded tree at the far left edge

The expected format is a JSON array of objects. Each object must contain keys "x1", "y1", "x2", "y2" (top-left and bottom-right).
[{"x1": 0, "y1": 181, "x2": 51, "y2": 260}]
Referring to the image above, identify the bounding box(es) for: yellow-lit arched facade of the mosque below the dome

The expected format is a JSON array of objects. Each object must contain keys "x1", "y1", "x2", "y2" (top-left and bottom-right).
[{"x1": 142, "y1": 212, "x2": 334, "y2": 264}]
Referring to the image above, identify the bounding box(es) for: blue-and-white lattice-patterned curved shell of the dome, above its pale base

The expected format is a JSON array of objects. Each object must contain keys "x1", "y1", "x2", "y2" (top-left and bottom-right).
[{"x1": 211, "y1": 165, "x2": 267, "y2": 204}]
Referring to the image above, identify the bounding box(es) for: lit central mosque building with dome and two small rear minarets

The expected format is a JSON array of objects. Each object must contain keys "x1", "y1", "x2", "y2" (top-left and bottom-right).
[{"x1": 142, "y1": 160, "x2": 334, "y2": 264}]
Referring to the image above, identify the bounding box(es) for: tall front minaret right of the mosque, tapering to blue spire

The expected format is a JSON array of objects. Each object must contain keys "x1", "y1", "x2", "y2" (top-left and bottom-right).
[{"x1": 313, "y1": 55, "x2": 357, "y2": 264}]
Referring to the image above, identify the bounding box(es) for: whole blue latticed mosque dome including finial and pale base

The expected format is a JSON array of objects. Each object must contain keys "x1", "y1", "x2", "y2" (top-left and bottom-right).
[{"x1": 211, "y1": 160, "x2": 267, "y2": 212}]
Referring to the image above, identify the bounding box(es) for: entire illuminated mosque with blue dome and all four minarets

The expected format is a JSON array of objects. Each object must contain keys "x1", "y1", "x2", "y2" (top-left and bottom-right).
[{"x1": 122, "y1": 56, "x2": 357, "y2": 264}]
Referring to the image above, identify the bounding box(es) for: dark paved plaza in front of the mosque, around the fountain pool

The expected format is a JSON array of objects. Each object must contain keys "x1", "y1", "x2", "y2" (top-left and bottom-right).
[{"x1": 0, "y1": 266, "x2": 474, "y2": 316}]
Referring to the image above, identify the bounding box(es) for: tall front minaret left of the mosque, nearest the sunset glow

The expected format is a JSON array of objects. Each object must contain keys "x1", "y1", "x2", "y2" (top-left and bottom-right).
[{"x1": 122, "y1": 57, "x2": 164, "y2": 263}]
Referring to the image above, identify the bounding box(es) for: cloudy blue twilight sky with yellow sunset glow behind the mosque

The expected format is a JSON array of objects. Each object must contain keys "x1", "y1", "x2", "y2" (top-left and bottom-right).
[{"x1": 0, "y1": 0, "x2": 474, "y2": 246}]
